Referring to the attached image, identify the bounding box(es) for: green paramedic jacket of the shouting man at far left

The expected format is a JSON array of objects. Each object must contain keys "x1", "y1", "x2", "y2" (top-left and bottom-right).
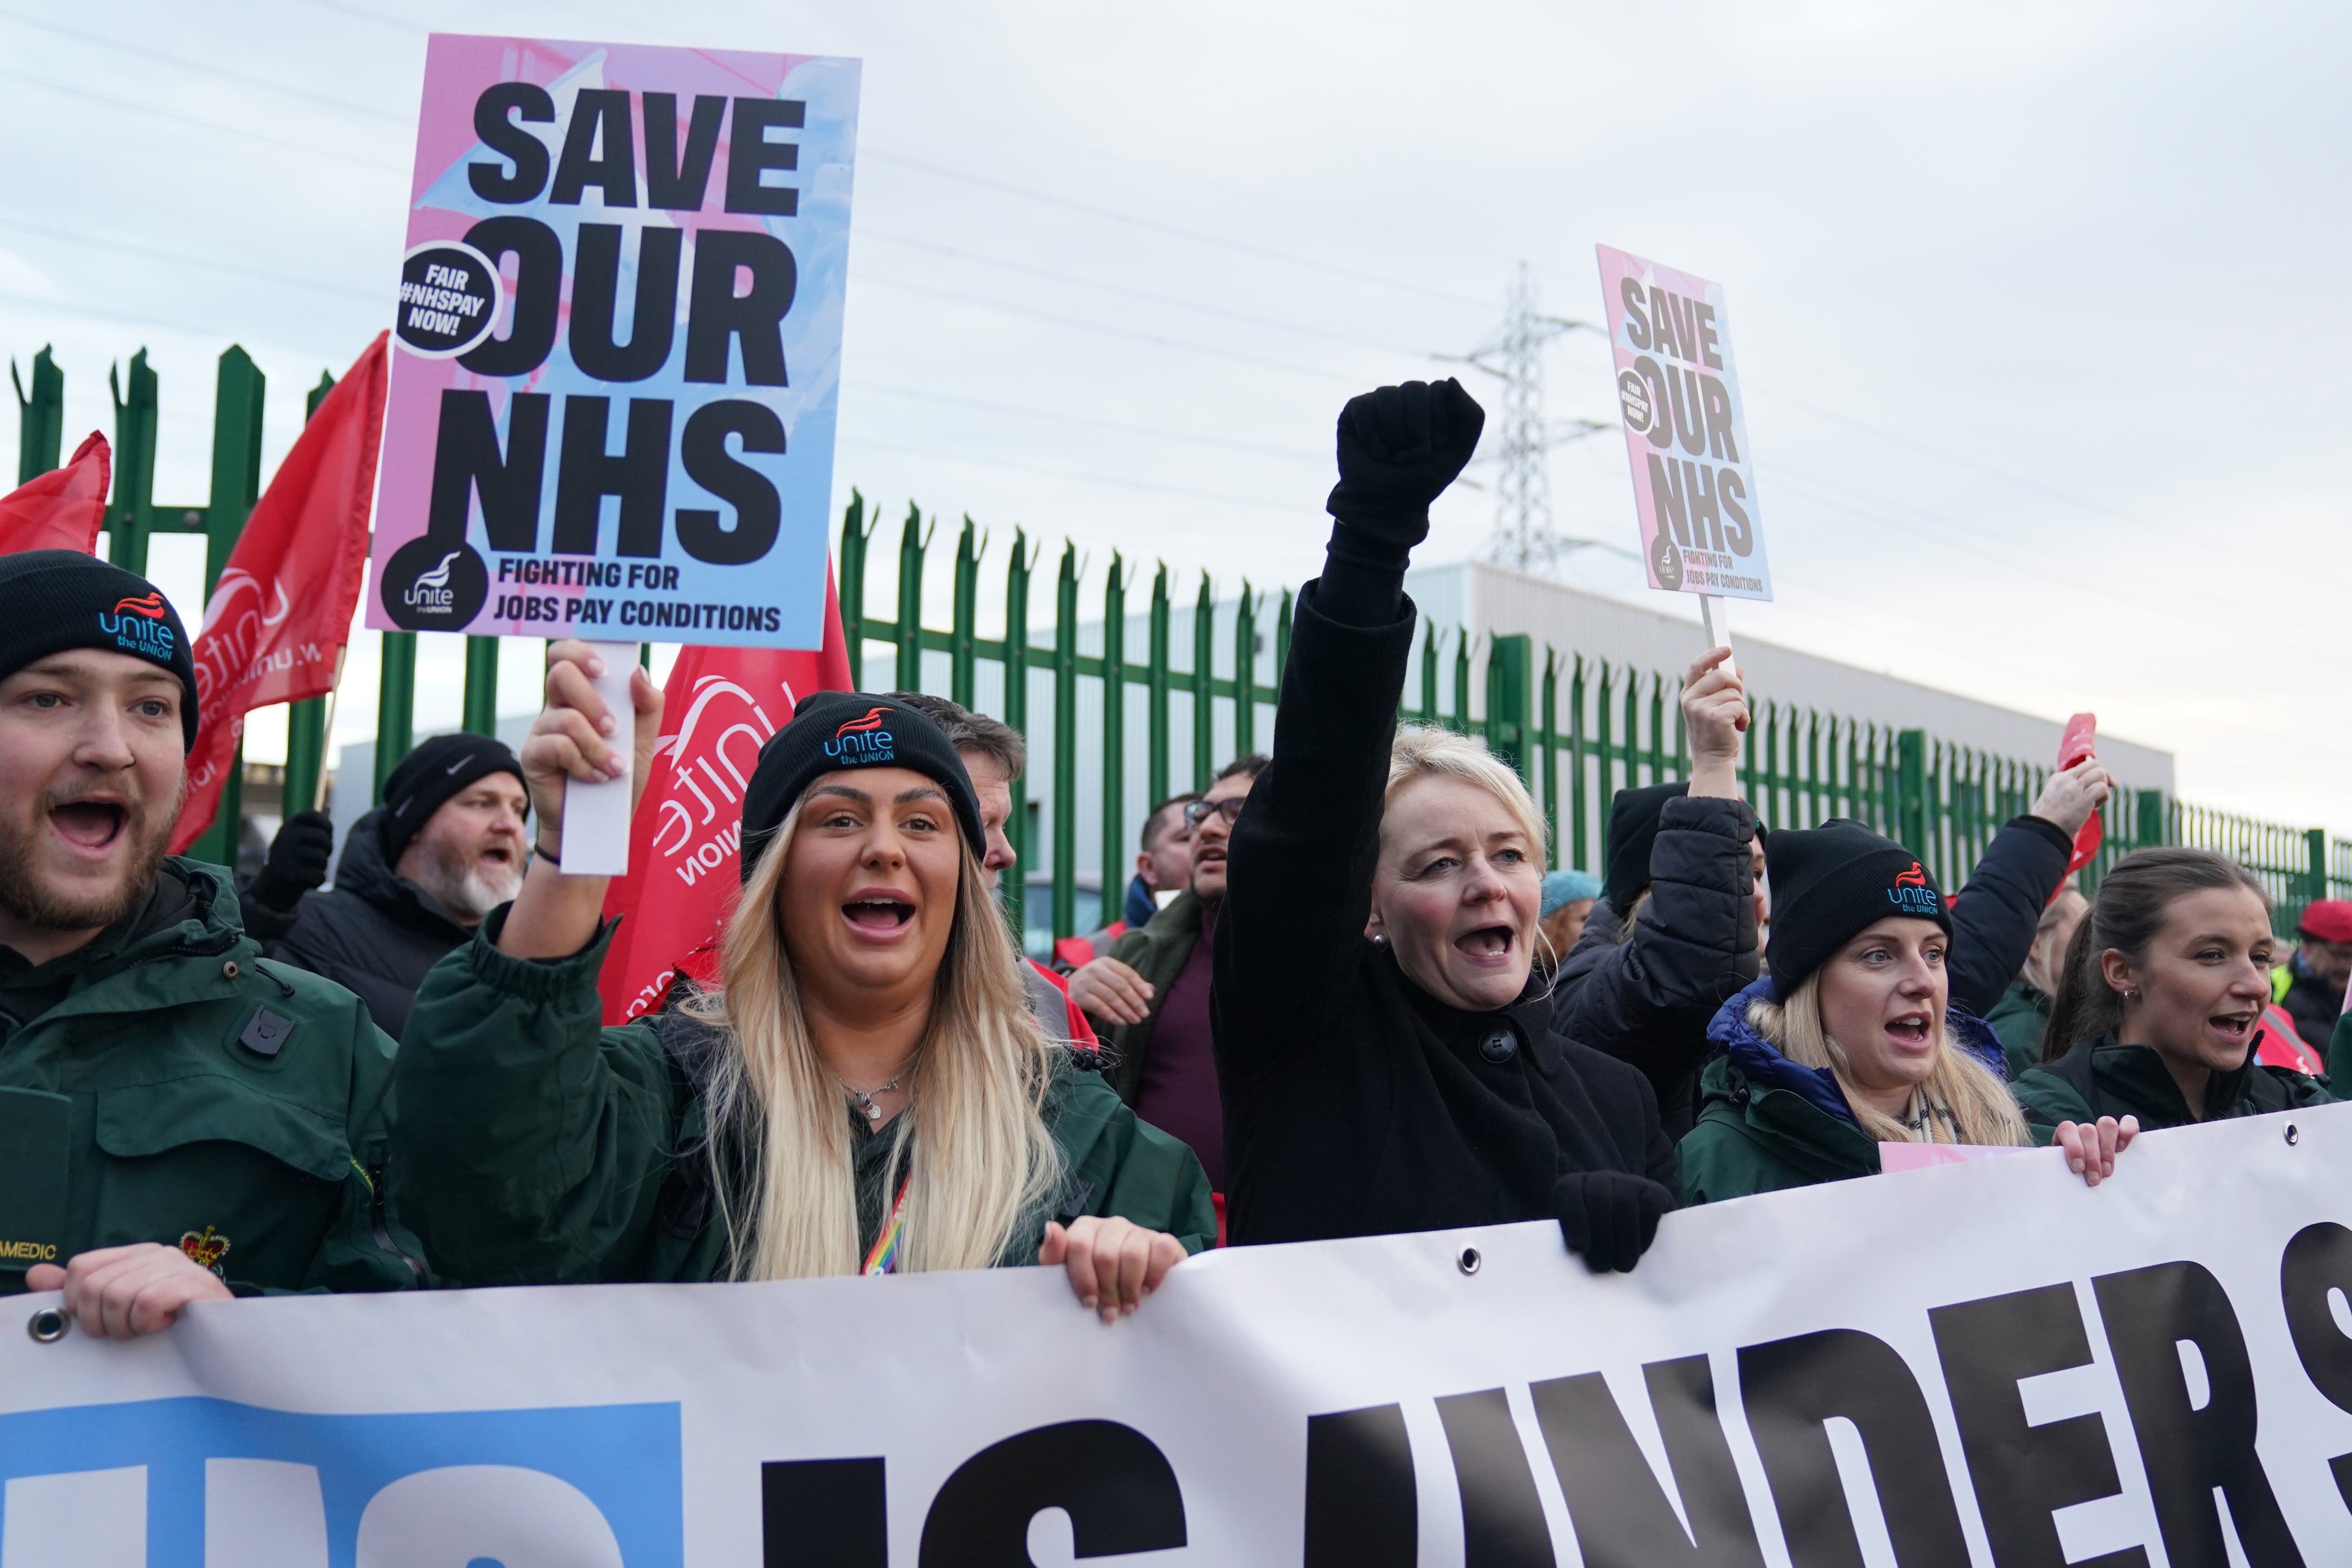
[{"x1": 0, "y1": 858, "x2": 426, "y2": 1295}]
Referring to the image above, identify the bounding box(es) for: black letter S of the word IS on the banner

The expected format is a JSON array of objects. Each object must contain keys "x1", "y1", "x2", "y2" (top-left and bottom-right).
[{"x1": 912, "y1": 1420, "x2": 1185, "y2": 1568}]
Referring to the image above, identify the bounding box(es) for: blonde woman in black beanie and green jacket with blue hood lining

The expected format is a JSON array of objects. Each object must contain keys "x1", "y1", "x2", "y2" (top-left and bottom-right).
[{"x1": 1680, "y1": 820, "x2": 2136, "y2": 1204}]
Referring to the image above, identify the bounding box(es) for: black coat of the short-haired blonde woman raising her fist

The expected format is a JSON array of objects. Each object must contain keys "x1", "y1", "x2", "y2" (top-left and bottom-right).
[{"x1": 1209, "y1": 583, "x2": 1675, "y2": 1251}]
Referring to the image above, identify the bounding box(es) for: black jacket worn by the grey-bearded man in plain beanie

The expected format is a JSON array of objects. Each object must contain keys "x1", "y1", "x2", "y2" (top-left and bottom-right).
[{"x1": 270, "y1": 811, "x2": 473, "y2": 1039}]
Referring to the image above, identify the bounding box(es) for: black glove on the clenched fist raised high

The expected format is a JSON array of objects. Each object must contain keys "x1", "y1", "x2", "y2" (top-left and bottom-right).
[{"x1": 1327, "y1": 376, "x2": 1487, "y2": 557}]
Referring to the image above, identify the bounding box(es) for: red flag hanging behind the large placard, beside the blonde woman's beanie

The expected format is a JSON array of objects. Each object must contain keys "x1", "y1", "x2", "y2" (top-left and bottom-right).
[{"x1": 597, "y1": 569, "x2": 851, "y2": 1023}]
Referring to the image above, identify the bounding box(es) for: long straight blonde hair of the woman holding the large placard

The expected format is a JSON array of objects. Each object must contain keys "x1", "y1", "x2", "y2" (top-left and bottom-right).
[{"x1": 687, "y1": 804, "x2": 1061, "y2": 1279}]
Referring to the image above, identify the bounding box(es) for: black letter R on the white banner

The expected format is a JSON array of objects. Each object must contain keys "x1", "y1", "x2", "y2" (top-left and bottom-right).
[{"x1": 2091, "y1": 1263, "x2": 2303, "y2": 1568}]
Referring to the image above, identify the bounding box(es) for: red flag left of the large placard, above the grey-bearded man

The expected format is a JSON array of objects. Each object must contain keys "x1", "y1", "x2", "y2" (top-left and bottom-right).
[{"x1": 172, "y1": 331, "x2": 386, "y2": 853}]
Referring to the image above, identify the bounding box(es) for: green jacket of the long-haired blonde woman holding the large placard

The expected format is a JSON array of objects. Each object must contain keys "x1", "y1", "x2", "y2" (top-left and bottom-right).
[{"x1": 393, "y1": 910, "x2": 1216, "y2": 1286}]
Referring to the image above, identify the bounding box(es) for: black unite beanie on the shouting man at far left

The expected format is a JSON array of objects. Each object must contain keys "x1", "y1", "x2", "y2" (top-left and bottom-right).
[{"x1": 0, "y1": 550, "x2": 197, "y2": 750}]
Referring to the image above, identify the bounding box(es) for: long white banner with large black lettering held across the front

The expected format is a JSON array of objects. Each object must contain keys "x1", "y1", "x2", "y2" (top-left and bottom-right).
[{"x1": 0, "y1": 1107, "x2": 2352, "y2": 1568}]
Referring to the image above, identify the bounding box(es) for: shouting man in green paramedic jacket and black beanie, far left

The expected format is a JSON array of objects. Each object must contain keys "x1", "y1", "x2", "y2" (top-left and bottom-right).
[{"x1": 0, "y1": 550, "x2": 426, "y2": 1335}]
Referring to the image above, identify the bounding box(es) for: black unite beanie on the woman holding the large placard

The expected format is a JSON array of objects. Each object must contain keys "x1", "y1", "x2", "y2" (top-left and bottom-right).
[{"x1": 743, "y1": 691, "x2": 988, "y2": 882}]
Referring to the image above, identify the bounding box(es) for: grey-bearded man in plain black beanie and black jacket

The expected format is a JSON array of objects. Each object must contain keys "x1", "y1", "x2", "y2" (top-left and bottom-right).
[{"x1": 270, "y1": 733, "x2": 531, "y2": 1039}]
